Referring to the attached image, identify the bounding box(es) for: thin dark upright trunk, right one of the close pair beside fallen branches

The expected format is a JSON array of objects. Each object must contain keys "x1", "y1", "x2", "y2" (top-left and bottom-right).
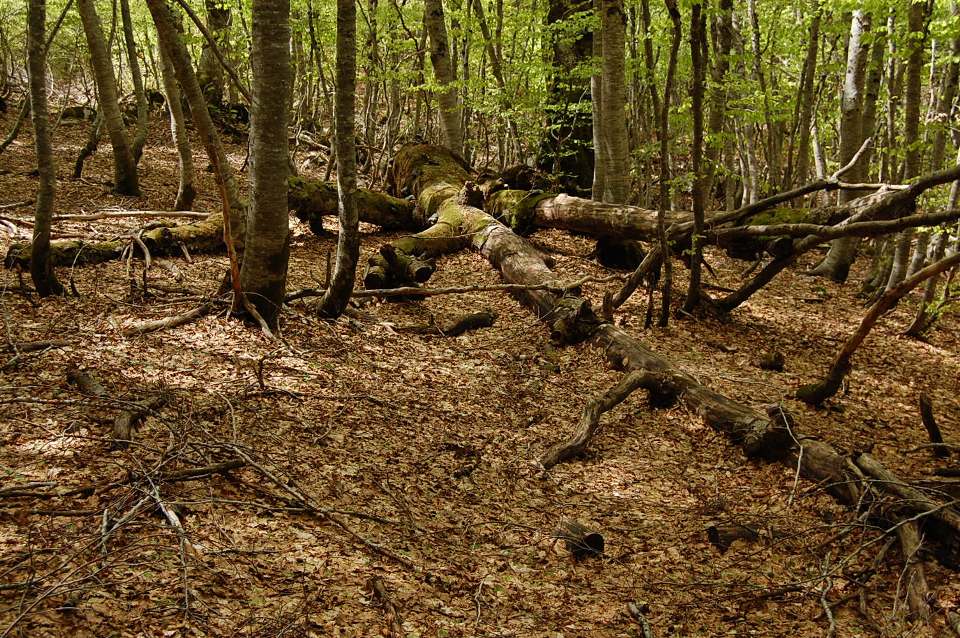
[{"x1": 683, "y1": 2, "x2": 707, "y2": 313}]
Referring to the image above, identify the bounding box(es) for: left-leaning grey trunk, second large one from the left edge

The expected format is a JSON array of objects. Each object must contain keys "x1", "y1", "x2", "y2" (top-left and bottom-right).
[{"x1": 77, "y1": 0, "x2": 140, "y2": 195}]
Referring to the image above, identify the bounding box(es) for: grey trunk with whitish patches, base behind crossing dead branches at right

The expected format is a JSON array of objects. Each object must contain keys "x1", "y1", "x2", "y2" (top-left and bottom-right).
[{"x1": 810, "y1": 9, "x2": 870, "y2": 283}]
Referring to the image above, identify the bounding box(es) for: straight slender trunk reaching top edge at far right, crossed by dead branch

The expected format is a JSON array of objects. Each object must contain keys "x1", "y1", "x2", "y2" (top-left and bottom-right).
[{"x1": 887, "y1": 2, "x2": 927, "y2": 290}]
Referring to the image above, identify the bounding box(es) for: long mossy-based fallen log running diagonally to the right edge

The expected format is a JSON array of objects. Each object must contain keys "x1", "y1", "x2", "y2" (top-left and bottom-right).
[{"x1": 380, "y1": 145, "x2": 960, "y2": 580}]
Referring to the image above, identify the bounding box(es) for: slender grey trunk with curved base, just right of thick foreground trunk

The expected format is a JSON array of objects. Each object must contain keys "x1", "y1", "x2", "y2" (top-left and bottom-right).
[{"x1": 319, "y1": 0, "x2": 360, "y2": 317}]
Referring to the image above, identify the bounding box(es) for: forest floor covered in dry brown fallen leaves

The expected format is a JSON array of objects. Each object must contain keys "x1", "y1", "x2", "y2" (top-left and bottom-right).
[{"x1": 0, "y1": 114, "x2": 960, "y2": 637}]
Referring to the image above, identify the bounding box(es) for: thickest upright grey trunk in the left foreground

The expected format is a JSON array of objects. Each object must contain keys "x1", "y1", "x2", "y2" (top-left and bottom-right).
[{"x1": 240, "y1": 0, "x2": 292, "y2": 328}]
